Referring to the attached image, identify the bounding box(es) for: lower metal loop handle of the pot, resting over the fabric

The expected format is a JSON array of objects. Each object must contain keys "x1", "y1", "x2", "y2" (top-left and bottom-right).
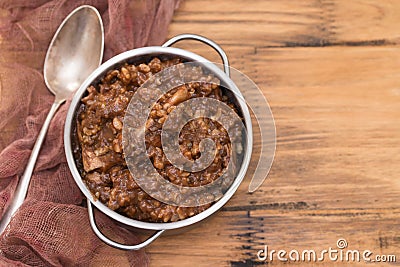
[{"x1": 87, "y1": 199, "x2": 165, "y2": 250}]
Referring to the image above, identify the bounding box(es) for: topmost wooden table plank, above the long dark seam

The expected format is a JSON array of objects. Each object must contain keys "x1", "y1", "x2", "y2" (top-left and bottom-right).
[{"x1": 170, "y1": 0, "x2": 400, "y2": 47}]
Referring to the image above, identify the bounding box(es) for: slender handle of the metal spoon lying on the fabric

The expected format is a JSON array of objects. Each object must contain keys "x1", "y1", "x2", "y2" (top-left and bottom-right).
[{"x1": 0, "y1": 101, "x2": 63, "y2": 235}]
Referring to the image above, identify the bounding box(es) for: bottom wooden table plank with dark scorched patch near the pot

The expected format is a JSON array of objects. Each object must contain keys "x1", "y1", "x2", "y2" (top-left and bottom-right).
[{"x1": 148, "y1": 210, "x2": 400, "y2": 266}]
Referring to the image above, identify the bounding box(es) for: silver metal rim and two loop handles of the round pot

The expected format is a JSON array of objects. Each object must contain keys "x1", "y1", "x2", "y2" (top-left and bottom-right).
[{"x1": 64, "y1": 34, "x2": 253, "y2": 250}]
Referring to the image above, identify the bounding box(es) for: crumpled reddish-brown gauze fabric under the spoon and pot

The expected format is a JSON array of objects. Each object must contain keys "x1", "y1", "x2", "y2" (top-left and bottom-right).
[{"x1": 0, "y1": 0, "x2": 179, "y2": 266}]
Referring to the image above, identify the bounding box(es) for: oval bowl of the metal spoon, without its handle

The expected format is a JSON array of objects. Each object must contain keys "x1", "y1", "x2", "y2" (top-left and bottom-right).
[{"x1": 43, "y1": 5, "x2": 104, "y2": 101}]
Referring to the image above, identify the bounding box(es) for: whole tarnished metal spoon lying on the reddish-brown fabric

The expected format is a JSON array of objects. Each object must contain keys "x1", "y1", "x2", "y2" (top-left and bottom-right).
[{"x1": 0, "y1": 5, "x2": 104, "y2": 234}]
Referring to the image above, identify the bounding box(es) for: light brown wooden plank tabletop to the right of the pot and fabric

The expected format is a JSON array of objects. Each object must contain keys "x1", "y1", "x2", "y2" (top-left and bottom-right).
[{"x1": 147, "y1": 0, "x2": 400, "y2": 266}]
